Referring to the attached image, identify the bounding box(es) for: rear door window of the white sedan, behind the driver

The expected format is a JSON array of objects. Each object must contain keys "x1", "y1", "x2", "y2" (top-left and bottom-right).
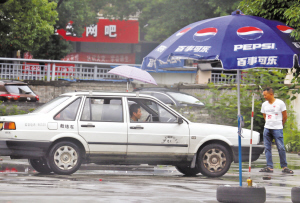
[{"x1": 80, "y1": 98, "x2": 123, "y2": 122}]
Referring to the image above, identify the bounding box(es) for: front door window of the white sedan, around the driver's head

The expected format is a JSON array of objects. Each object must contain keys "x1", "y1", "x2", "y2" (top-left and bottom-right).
[{"x1": 128, "y1": 98, "x2": 177, "y2": 123}]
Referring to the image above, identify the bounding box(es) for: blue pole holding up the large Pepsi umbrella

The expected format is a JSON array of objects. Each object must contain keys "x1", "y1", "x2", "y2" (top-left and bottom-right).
[{"x1": 237, "y1": 70, "x2": 242, "y2": 186}]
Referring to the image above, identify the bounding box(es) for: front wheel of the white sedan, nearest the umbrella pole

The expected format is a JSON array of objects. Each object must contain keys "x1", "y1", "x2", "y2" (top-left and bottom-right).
[{"x1": 197, "y1": 144, "x2": 232, "y2": 177}]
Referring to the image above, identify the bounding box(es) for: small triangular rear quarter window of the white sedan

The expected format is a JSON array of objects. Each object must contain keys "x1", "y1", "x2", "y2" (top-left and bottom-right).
[{"x1": 54, "y1": 98, "x2": 81, "y2": 121}]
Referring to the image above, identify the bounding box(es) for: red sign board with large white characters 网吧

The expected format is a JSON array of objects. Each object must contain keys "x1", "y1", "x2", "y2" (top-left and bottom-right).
[{"x1": 57, "y1": 19, "x2": 139, "y2": 44}]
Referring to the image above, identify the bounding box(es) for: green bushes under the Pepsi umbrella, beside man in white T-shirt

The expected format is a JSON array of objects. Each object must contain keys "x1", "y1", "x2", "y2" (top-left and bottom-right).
[{"x1": 199, "y1": 69, "x2": 294, "y2": 135}]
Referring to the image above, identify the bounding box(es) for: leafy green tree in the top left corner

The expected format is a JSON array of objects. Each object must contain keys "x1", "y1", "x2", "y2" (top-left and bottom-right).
[{"x1": 0, "y1": 0, "x2": 58, "y2": 56}]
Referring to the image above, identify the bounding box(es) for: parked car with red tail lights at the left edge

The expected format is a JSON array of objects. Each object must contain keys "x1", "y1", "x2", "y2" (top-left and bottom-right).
[{"x1": 0, "y1": 80, "x2": 39, "y2": 102}]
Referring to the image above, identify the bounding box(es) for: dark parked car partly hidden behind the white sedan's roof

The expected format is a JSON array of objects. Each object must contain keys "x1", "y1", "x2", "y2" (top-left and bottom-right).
[{"x1": 133, "y1": 87, "x2": 204, "y2": 107}]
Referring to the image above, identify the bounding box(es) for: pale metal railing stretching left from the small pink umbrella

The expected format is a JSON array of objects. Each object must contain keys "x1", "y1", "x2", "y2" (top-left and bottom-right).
[{"x1": 0, "y1": 57, "x2": 140, "y2": 81}]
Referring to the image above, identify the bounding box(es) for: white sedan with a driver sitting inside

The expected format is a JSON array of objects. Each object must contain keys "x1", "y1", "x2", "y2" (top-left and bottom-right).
[{"x1": 0, "y1": 91, "x2": 264, "y2": 177}]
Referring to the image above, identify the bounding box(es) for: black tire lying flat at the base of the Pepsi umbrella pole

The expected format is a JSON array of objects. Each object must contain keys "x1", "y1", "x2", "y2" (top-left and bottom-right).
[{"x1": 217, "y1": 186, "x2": 266, "y2": 203}]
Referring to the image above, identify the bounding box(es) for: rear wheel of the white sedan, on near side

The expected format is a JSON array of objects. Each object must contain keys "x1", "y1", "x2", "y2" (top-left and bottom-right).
[{"x1": 48, "y1": 141, "x2": 82, "y2": 175}]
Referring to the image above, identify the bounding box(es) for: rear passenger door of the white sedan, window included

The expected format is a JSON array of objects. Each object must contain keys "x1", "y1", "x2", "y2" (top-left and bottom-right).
[{"x1": 78, "y1": 96, "x2": 127, "y2": 163}]
